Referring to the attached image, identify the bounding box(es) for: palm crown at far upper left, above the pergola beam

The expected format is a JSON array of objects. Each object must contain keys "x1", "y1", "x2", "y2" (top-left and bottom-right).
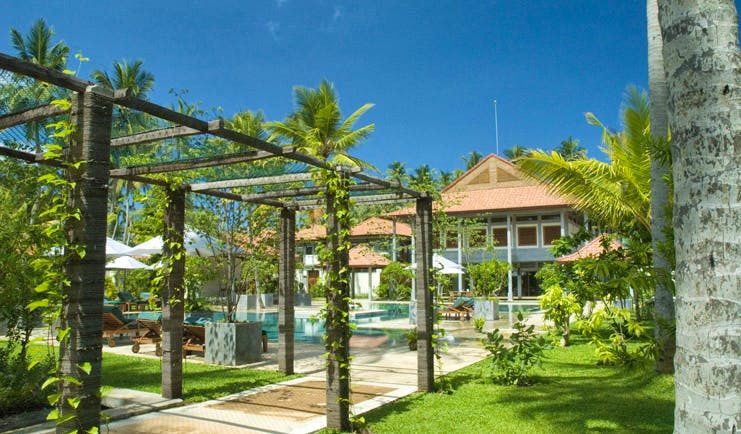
[{"x1": 10, "y1": 18, "x2": 69, "y2": 71}]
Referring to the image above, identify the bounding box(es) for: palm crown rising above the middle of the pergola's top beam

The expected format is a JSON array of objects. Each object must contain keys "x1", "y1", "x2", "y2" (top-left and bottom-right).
[{"x1": 266, "y1": 80, "x2": 376, "y2": 170}]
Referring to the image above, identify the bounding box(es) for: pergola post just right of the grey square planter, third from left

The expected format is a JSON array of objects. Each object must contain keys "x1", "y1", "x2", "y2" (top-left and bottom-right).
[{"x1": 278, "y1": 208, "x2": 296, "y2": 375}]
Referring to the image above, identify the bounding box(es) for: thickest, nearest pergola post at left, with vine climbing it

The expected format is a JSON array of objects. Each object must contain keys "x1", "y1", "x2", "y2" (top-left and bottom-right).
[{"x1": 56, "y1": 86, "x2": 112, "y2": 433}]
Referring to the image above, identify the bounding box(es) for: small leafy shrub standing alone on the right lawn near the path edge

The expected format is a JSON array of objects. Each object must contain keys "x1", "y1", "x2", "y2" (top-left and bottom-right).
[{"x1": 482, "y1": 312, "x2": 545, "y2": 386}]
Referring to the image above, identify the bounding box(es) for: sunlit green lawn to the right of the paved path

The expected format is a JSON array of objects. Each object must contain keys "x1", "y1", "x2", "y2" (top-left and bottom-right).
[{"x1": 364, "y1": 343, "x2": 674, "y2": 434}]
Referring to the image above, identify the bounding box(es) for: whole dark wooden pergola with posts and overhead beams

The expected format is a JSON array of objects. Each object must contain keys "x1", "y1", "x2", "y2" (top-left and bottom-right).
[{"x1": 0, "y1": 53, "x2": 434, "y2": 432}]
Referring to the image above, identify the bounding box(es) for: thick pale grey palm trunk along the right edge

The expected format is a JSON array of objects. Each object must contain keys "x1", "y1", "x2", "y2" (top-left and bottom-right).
[{"x1": 659, "y1": 0, "x2": 741, "y2": 433}]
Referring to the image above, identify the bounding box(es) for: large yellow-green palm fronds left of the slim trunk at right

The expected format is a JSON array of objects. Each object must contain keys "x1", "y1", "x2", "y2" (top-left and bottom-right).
[{"x1": 518, "y1": 87, "x2": 651, "y2": 240}]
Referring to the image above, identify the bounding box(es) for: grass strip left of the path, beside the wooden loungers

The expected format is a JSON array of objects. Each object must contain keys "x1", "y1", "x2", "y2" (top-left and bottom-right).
[{"x1": 103, "y1": 353, "x2": 296, "y2": 403}]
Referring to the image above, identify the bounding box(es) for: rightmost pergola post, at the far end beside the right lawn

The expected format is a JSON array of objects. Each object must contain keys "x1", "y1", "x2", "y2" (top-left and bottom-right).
[{"x1": 415, "y1": 197, "x2": 435, "y2": 392}]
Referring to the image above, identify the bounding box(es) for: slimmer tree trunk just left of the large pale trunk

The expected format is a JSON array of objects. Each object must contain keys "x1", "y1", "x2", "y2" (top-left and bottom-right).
[{"x1": 646, "y1": 0, "x2": 676, "y2": 373}]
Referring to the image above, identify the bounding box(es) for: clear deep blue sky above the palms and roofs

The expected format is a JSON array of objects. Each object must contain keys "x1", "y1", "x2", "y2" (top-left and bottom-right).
[{"x1": 0, "y1": 0, "x2": 647, "y2": 175}]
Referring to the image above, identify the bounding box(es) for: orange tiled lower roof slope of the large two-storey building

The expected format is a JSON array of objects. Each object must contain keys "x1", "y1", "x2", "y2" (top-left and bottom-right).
[{"x1": 387, "y1": 185, "x2": 571, "y2": 216}]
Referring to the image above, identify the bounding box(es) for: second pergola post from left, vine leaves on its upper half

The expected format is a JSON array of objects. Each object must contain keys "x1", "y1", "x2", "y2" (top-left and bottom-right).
[{"x1": 160, "y1": 188, "x2": 185, "y2": 399}]
